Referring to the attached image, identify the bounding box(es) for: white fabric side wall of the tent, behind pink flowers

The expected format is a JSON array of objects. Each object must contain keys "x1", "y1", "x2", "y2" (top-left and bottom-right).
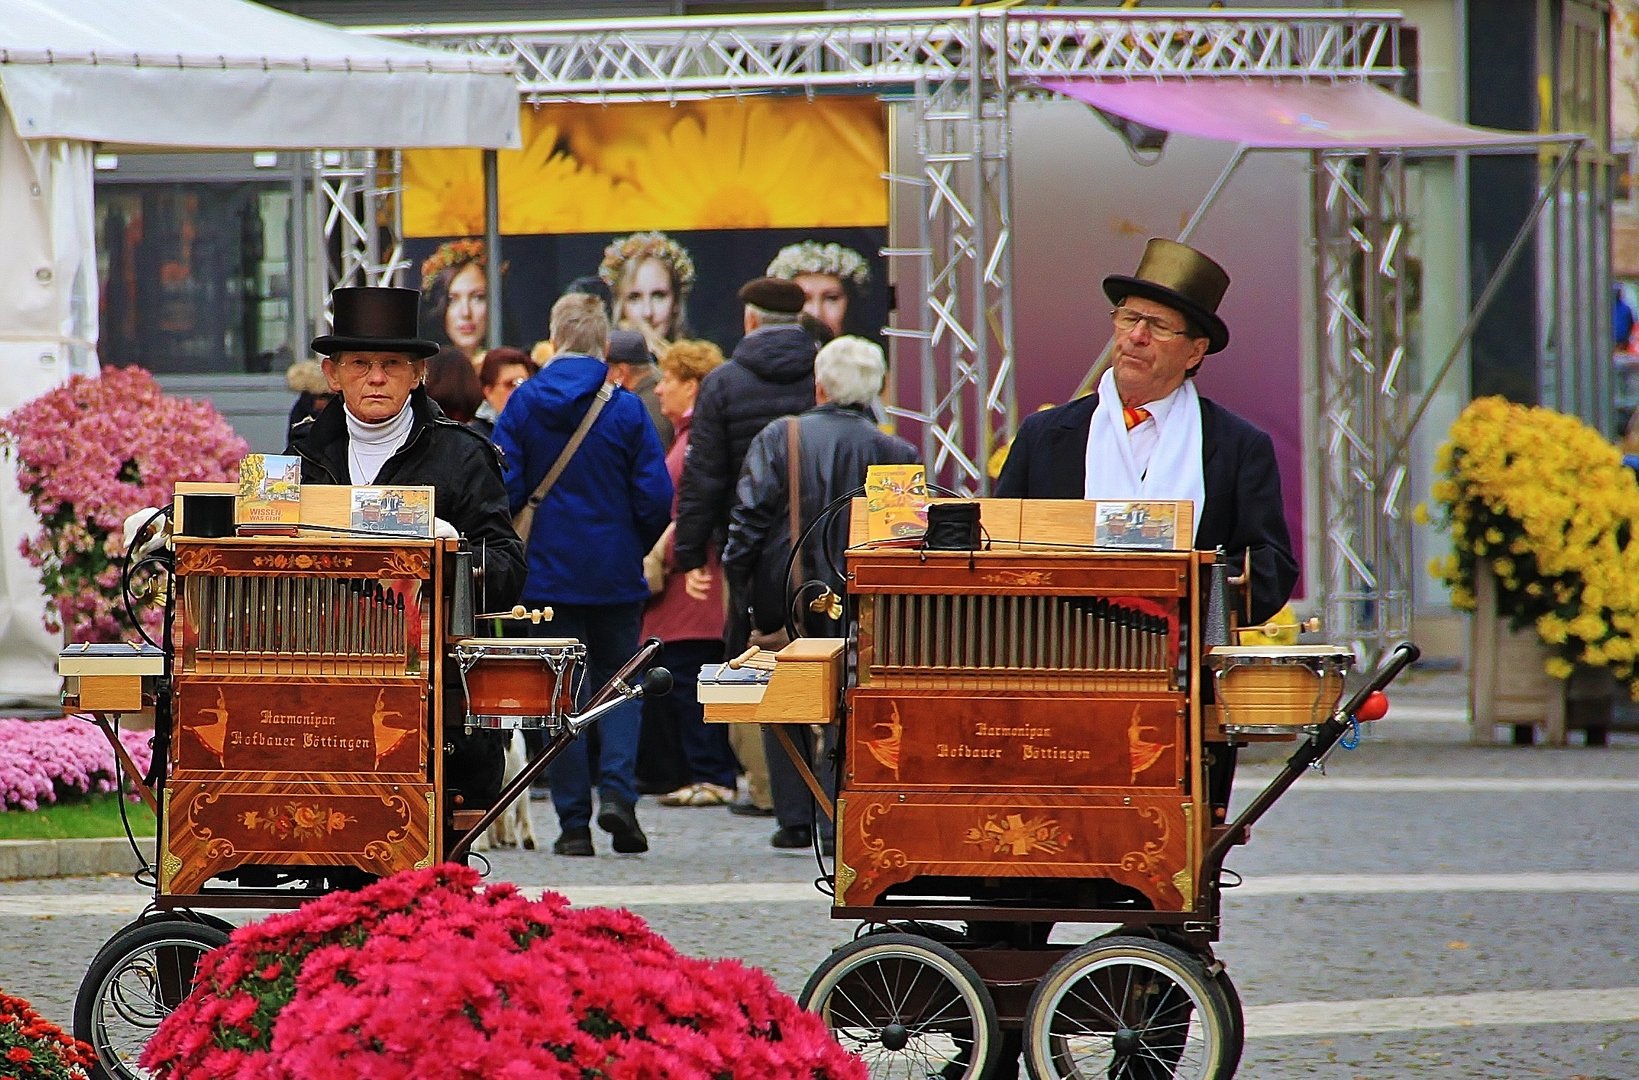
[{"x1": 0, "y1": 108, "x2": 97, "y2": 705}]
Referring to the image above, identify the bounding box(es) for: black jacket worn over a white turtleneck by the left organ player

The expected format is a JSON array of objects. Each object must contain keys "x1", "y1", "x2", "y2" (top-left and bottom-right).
[{"x1": 285, "y1": 387, "x2": 523, "y2": 611}]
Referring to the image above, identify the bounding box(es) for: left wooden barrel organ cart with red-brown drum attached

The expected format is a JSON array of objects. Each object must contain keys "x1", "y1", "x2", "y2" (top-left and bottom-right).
[{"x1": 59, "y1": 485, "x2": 670, "y2": 1078}]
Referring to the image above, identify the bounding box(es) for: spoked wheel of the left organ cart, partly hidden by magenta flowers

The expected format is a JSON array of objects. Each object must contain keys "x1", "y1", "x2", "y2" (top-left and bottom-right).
[{"x1": 74, "y1": 918, "x2": 228, "y2": 1080}]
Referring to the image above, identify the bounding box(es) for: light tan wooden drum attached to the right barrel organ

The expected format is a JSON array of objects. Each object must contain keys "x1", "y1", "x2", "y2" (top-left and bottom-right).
[{"x1": 1206, "y1": 646, "x2": 1354, "y2": 736}]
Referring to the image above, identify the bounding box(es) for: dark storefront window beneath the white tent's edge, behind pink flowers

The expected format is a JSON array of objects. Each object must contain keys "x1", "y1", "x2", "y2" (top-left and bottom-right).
[{"x1": 97, "y1": 182, "x2": 290, "y2": 374}]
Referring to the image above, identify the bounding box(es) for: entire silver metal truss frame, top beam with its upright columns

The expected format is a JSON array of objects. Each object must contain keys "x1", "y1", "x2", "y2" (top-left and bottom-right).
[{"x1": 358, "y1": 5, "x2": 1435, "y2": 652}]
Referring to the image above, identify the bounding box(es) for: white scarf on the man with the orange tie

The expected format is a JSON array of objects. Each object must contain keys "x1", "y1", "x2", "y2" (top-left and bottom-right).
[{"x1": 1083, "y1": 369, "x2": 1206, "y2": 541}]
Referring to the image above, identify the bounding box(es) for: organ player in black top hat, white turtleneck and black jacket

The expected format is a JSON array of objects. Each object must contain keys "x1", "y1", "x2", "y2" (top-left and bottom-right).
[{"x1": 285, "y1": 288, "x2": 524, "y2": 844}]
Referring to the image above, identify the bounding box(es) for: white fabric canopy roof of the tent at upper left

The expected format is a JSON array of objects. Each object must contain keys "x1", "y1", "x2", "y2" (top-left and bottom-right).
[{"x1": 0, "y1": 0, "x2": 521, "y2": 149}]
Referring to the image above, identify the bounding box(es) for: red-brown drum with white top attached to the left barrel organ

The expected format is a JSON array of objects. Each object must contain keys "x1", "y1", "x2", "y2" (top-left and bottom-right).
[{"x1": 456, "y1": 638, "x2": 587, "y2": 731}]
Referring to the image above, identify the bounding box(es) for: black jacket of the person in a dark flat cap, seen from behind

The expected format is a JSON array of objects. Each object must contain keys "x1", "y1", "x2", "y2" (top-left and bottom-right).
[{"x1": 672, "y1": 326, "x2": 815, "y2": 570}]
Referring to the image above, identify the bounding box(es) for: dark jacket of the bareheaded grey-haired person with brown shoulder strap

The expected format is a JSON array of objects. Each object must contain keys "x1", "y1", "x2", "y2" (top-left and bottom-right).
[{"x1": 723, "y1": 405, "x2": 921, "y2": 634}]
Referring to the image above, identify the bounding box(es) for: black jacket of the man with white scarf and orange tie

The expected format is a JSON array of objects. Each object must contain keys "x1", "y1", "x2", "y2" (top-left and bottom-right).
[{"x1": 995, "y1": 393, "x2": 1298, "y2": 623}]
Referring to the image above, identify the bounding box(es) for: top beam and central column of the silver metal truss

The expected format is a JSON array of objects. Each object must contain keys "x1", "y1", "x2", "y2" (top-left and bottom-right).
[{"x1": 370, "y1": 7, "x2": 1398, "y2": 492}]
